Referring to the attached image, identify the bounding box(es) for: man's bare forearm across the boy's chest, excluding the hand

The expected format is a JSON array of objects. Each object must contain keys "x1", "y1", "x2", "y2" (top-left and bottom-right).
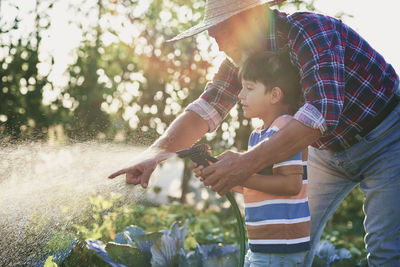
[{"x1": 242, "y1": 120, "x2": 321, "y2": 173}]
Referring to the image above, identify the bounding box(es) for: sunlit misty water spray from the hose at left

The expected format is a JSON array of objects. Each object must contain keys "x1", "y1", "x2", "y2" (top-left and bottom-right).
[{"x1": 0, "y1": 142, "x2": 144, "y2": 267}]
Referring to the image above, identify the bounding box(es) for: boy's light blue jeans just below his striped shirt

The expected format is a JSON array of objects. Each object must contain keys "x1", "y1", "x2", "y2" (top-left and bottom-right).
[{"x1": 244, "y1": 249, "x2": 306, "y2": 267}]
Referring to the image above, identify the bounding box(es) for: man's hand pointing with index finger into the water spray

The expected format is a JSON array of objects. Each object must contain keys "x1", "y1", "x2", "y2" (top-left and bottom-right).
[{"x1": 108, "y1": 158, "x2": 158, "y2": 188}]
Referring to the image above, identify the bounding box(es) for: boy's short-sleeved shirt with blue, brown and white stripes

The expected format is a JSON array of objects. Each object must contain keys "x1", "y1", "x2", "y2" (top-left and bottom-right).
[{"x1": 242, "y1": 115, "x2": 310, "y2": 253}]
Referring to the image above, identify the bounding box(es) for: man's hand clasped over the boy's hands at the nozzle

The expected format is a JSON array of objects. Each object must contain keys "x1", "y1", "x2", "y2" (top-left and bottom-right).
[{"x1": 202, "y1": 151, "x2": 251, "y2": 196}]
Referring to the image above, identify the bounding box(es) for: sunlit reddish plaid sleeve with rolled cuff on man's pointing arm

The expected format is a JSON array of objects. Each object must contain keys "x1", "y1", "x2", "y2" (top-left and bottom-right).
[{"x1": 186, "y1": 59, "x2": 242, "y2": 132}]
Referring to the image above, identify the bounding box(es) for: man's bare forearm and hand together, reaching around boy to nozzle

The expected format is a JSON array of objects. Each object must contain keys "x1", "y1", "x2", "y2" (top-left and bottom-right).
[{"x1": 194, "y1": 120, "x2": 321, "y2": 195}]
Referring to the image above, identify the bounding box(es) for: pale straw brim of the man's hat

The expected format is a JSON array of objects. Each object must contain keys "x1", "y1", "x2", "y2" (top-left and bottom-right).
[{"x1": 166, "y1": 0, "x2": 269, "y2": 42}]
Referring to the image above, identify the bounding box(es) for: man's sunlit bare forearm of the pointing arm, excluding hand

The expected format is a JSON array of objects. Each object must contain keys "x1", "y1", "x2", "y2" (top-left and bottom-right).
[{"x1": 151, "y1": 110, "x2": 208, "y2": 152}]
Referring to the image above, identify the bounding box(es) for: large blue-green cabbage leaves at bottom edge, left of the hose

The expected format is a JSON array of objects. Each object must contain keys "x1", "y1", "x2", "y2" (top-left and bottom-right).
[{"x1": 86, "y1": 220, "x2": 239, "y2": 267}]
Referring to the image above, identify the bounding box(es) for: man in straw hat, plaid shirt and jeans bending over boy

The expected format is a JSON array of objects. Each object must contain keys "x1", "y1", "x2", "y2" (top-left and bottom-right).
[{"x1": 110, "y1": 0, "x2": 400, "y2": 266}]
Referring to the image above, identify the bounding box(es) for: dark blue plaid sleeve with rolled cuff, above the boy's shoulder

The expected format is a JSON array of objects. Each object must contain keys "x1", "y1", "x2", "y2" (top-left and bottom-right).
[{"x1": 289, "y1": 16, "x2": 345, "y2": 133}]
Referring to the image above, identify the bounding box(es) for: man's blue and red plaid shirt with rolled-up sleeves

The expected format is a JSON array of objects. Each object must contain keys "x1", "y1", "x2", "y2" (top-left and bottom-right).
[{"x1": 187, "y1": 8, "x2": 398, "y2": 150}]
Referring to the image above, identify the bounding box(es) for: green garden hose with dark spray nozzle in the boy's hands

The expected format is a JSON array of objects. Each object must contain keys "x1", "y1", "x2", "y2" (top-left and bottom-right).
[{"x1": 176, "y1": 144, "x2": 246, "y2": 267}]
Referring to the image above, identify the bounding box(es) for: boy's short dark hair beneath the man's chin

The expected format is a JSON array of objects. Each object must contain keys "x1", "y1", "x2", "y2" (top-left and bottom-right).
[{"x1": 239, "y1": 48, "x2": 304, "y2": 114}]
